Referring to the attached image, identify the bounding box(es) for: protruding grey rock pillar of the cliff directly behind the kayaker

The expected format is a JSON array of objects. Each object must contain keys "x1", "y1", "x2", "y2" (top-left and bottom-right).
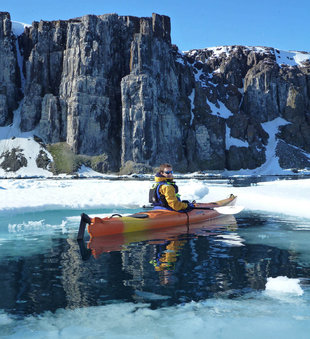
[{"x1": 121, "y1": 26, "x2": 190, "y2": 169}]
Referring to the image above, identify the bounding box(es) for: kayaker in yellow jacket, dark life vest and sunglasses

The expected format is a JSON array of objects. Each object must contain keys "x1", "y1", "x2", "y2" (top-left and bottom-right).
[{"x1": 149, "y1": 163, "x2": 194, "y2": 212}]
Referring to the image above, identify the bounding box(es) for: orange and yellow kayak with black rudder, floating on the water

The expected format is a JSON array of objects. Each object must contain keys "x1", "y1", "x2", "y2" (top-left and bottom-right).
[{"x1": 78, "y1": 195, "x2": 240, "y2": 239}]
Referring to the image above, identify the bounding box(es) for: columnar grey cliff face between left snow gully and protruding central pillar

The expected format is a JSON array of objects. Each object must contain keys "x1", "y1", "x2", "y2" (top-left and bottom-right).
[{"x1": 17, "y1": 14, "x2": 174, "y2": 170}]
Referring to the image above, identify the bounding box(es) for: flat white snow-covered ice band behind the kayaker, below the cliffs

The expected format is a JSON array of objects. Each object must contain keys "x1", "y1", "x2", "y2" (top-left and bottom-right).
[{"x1": 0, "y1": 179, "x2": 310, "y2": 218}]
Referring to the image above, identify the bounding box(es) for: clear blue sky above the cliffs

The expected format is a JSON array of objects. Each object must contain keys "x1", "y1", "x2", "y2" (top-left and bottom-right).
[{"x1": 0, "y1": 0, "x2": 310, "y2": 52}]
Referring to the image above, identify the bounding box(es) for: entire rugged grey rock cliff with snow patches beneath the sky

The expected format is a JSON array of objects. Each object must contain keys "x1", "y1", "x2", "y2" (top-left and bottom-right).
[{"x1": 0, "y1": 13, "x2": 310, "y2": 172}]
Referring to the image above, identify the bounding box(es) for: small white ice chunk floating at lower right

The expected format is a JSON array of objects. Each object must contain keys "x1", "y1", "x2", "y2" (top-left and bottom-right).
[{"x1": 266, "y1": 276, "x2": 304, "y2": 295}]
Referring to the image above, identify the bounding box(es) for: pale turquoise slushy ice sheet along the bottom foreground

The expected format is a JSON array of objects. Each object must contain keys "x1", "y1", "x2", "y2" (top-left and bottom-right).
[{"x1": 0, "y1": 277, "x2": 310, "y2": 339}]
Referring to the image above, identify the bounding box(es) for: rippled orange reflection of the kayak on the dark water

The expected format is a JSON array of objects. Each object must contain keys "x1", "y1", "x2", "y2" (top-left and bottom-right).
[{"x1": 87, "y1": 215, "x2": 237, "y2": 258}]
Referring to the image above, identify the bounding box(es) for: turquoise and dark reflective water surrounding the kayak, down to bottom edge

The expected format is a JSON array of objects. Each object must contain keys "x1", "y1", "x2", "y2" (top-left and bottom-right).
[{"x1": 0, "y1": 209, "x2": 310, "y2": 338}]
